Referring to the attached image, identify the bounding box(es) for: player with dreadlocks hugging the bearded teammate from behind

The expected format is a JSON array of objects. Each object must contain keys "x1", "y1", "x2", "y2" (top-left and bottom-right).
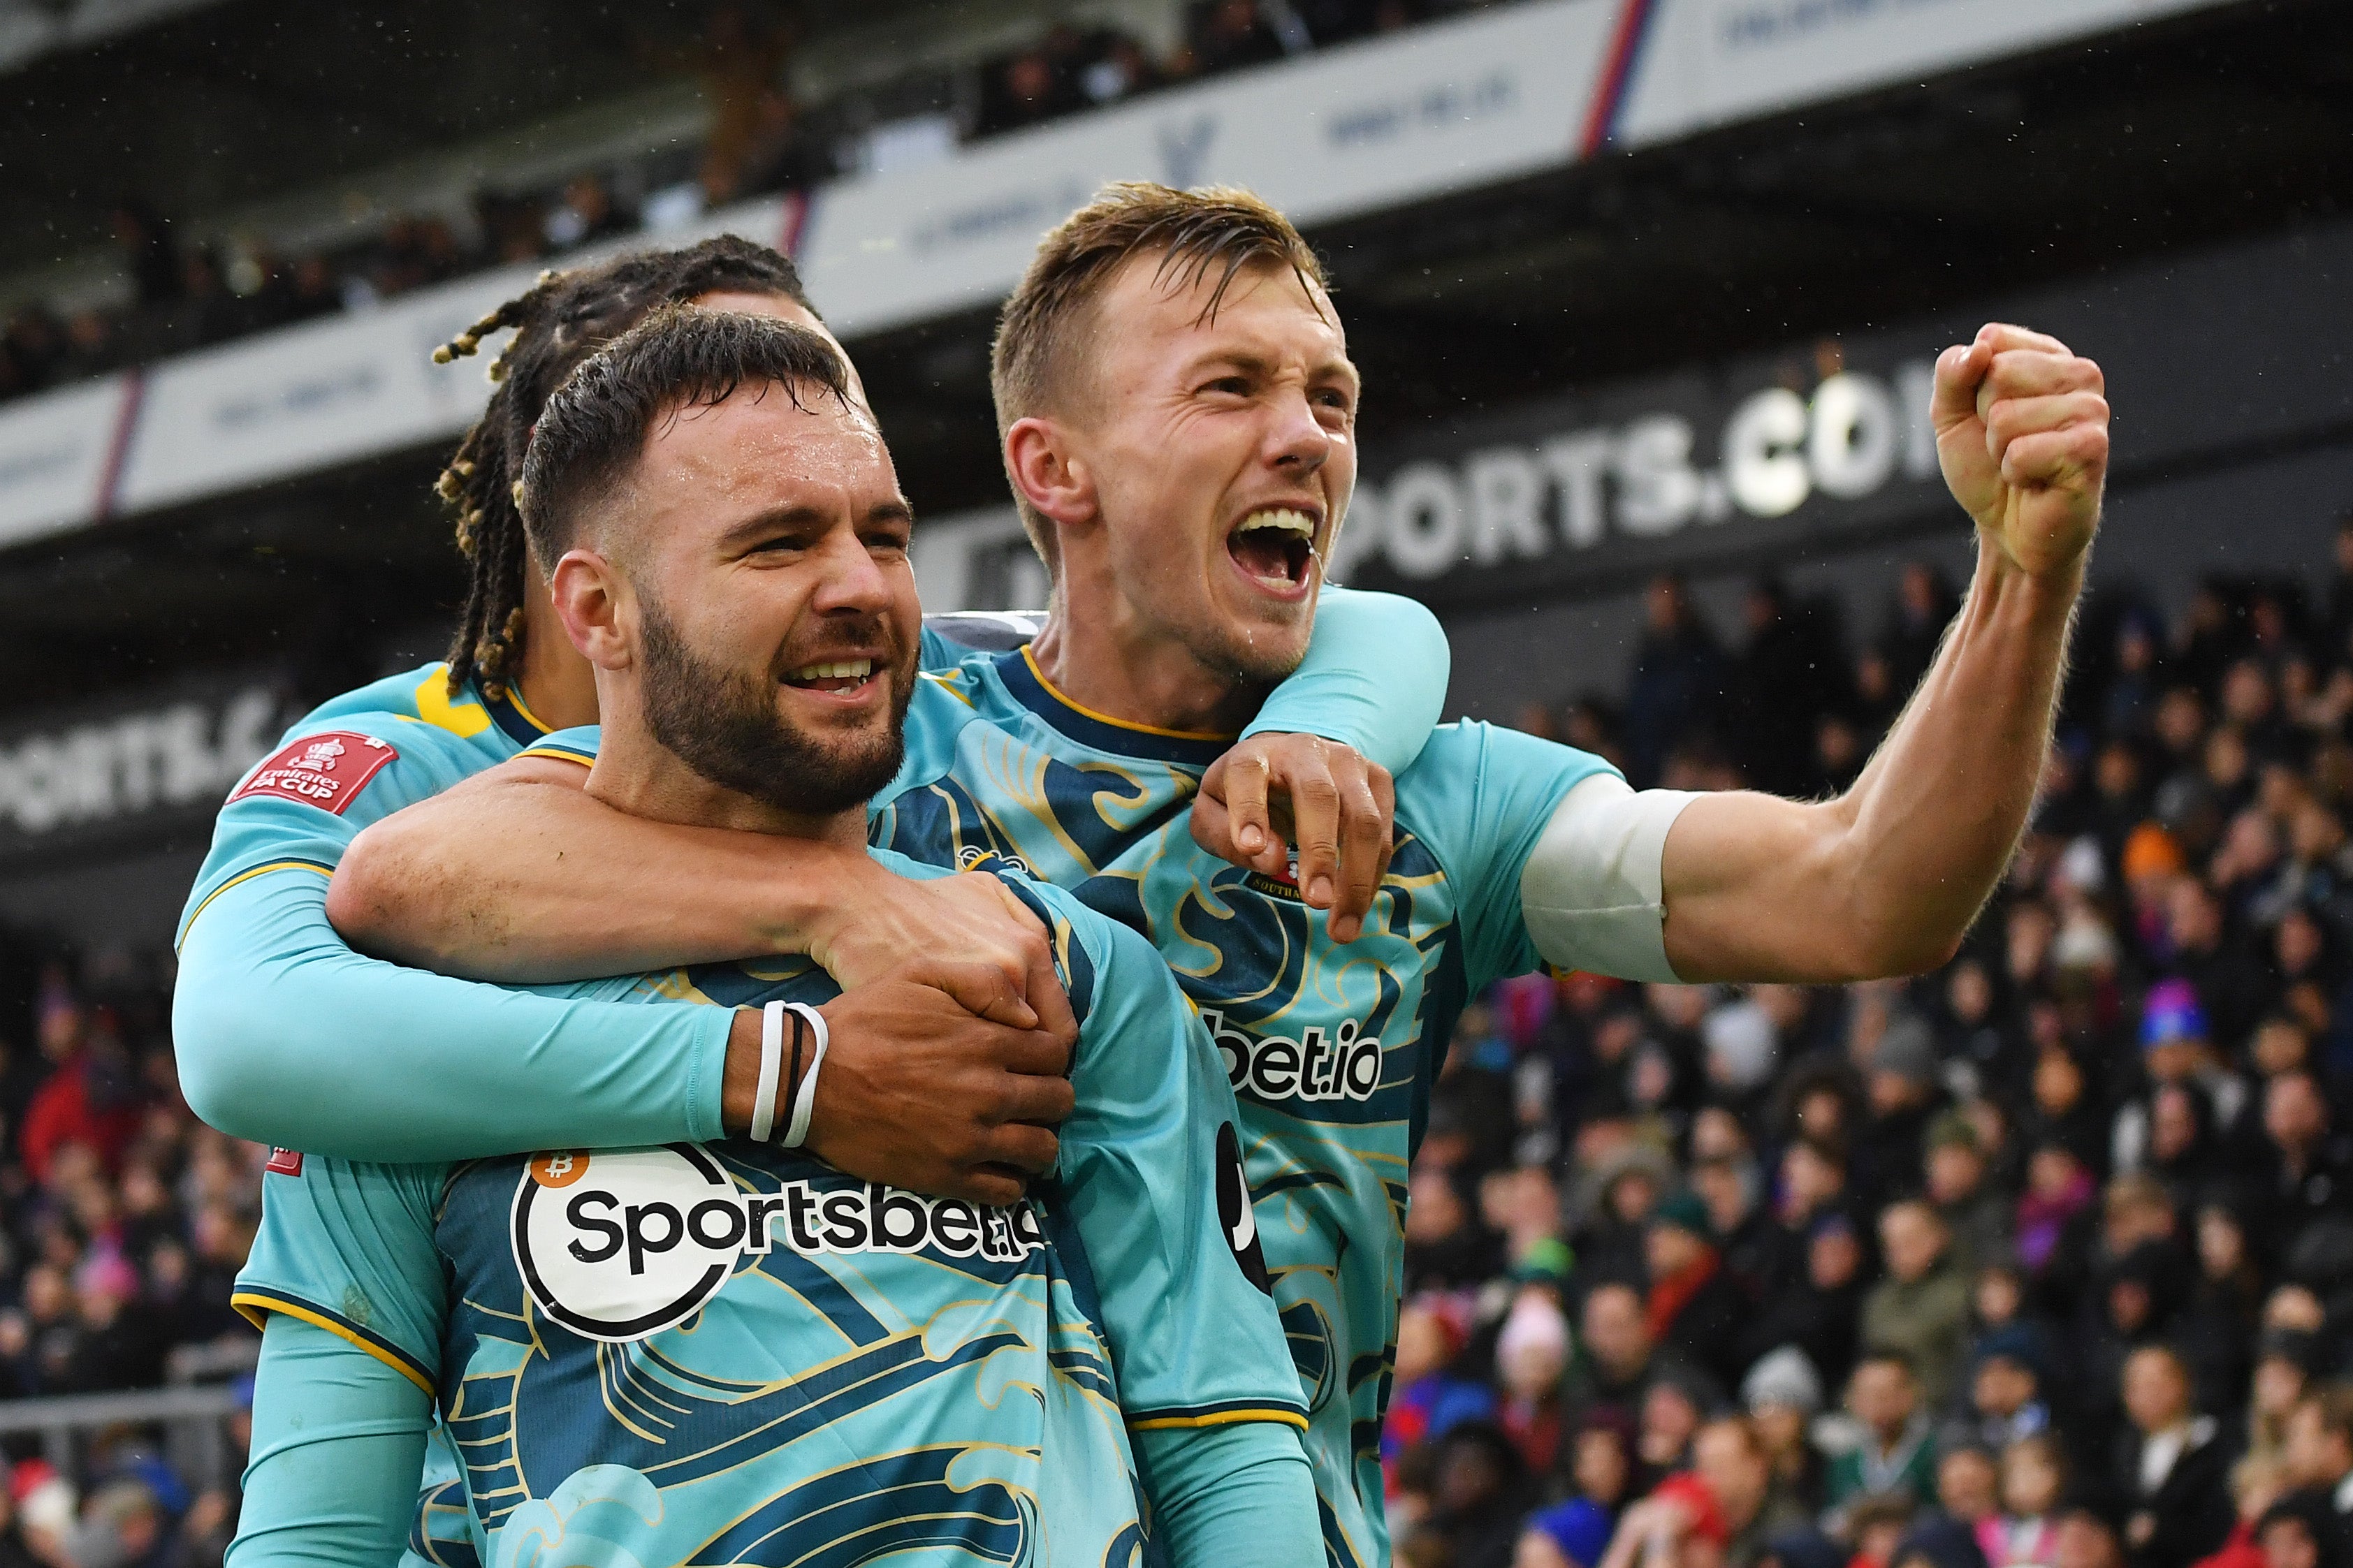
[{"x1": 174, "y1": 237, "x2": 1087, "y2": 1196}]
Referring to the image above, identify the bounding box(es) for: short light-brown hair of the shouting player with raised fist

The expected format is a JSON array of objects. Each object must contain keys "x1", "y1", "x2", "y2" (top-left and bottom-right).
[{"x1": 989, "y1": 181, "x2": 1332, "y2": 571}]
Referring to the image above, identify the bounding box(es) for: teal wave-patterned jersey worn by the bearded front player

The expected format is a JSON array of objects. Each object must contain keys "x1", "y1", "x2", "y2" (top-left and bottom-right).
[{"x1": 235, "y1": 841, "x2": 1306, "y2": 1568}]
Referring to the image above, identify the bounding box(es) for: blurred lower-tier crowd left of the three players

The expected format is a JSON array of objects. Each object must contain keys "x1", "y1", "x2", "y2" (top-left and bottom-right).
[{"x1": 0, "y1": 943, "x2": 266, "y2": 1568}]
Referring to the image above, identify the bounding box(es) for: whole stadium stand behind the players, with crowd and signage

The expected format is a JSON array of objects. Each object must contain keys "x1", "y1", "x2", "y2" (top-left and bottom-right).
[{"x1": 0, "y1": 0, "x2": 2353, "y2": 1568}]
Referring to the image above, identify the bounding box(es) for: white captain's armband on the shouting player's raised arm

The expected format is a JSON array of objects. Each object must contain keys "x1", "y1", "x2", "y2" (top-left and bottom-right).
[{"x1": 1520, "y1": 773, "x2": 1694, "y2": 985}]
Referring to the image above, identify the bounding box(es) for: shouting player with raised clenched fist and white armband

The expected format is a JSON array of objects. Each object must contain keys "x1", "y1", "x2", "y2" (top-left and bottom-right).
[{"x1": 334, "y1": 186, "x2": 2108, "y2": 1566}]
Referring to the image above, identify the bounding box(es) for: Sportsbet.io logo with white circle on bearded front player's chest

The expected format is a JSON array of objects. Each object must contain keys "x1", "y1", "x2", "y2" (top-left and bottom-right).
[{"x1": 508, "y1": 1143, "x2": 1044, "y2": 1342}]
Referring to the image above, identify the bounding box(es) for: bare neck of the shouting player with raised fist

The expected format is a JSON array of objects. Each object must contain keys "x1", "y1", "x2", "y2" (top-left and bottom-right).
[{"x1": 1030, "y1": 583, "x2": 1266, "y2": 736}]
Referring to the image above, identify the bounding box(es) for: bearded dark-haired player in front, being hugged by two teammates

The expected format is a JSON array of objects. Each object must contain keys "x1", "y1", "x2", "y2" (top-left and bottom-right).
[{"x1": 228, "y1": 308, "x2": 1318, "y2": 1568}]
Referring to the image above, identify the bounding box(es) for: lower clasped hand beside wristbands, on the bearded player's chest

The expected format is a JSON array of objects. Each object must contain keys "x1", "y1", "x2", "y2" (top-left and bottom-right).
[{"x1": 800, "y1": 976, "x2": 1073, "y2": 1203}]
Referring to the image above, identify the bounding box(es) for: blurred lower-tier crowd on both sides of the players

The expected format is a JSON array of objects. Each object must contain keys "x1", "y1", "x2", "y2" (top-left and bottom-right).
[{"x1": 0, "y1": 520, "x2": 2353, "y2": 1568}]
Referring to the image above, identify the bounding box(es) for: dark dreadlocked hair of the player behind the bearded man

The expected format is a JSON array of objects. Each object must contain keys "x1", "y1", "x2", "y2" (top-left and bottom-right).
[{"x1": 433, "y1": 235, "x2": 817, "y2": 696}]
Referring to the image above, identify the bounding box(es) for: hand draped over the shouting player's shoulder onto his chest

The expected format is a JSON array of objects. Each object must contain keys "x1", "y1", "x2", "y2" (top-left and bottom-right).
[{"x1": 1193, "y1": 736, "x2": 1398, "y2": 943}]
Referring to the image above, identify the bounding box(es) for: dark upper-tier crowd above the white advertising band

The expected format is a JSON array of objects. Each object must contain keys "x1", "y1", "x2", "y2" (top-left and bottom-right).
[{"x1": 0, "y1": 0, "x2": 1449, "y2": 402}]
